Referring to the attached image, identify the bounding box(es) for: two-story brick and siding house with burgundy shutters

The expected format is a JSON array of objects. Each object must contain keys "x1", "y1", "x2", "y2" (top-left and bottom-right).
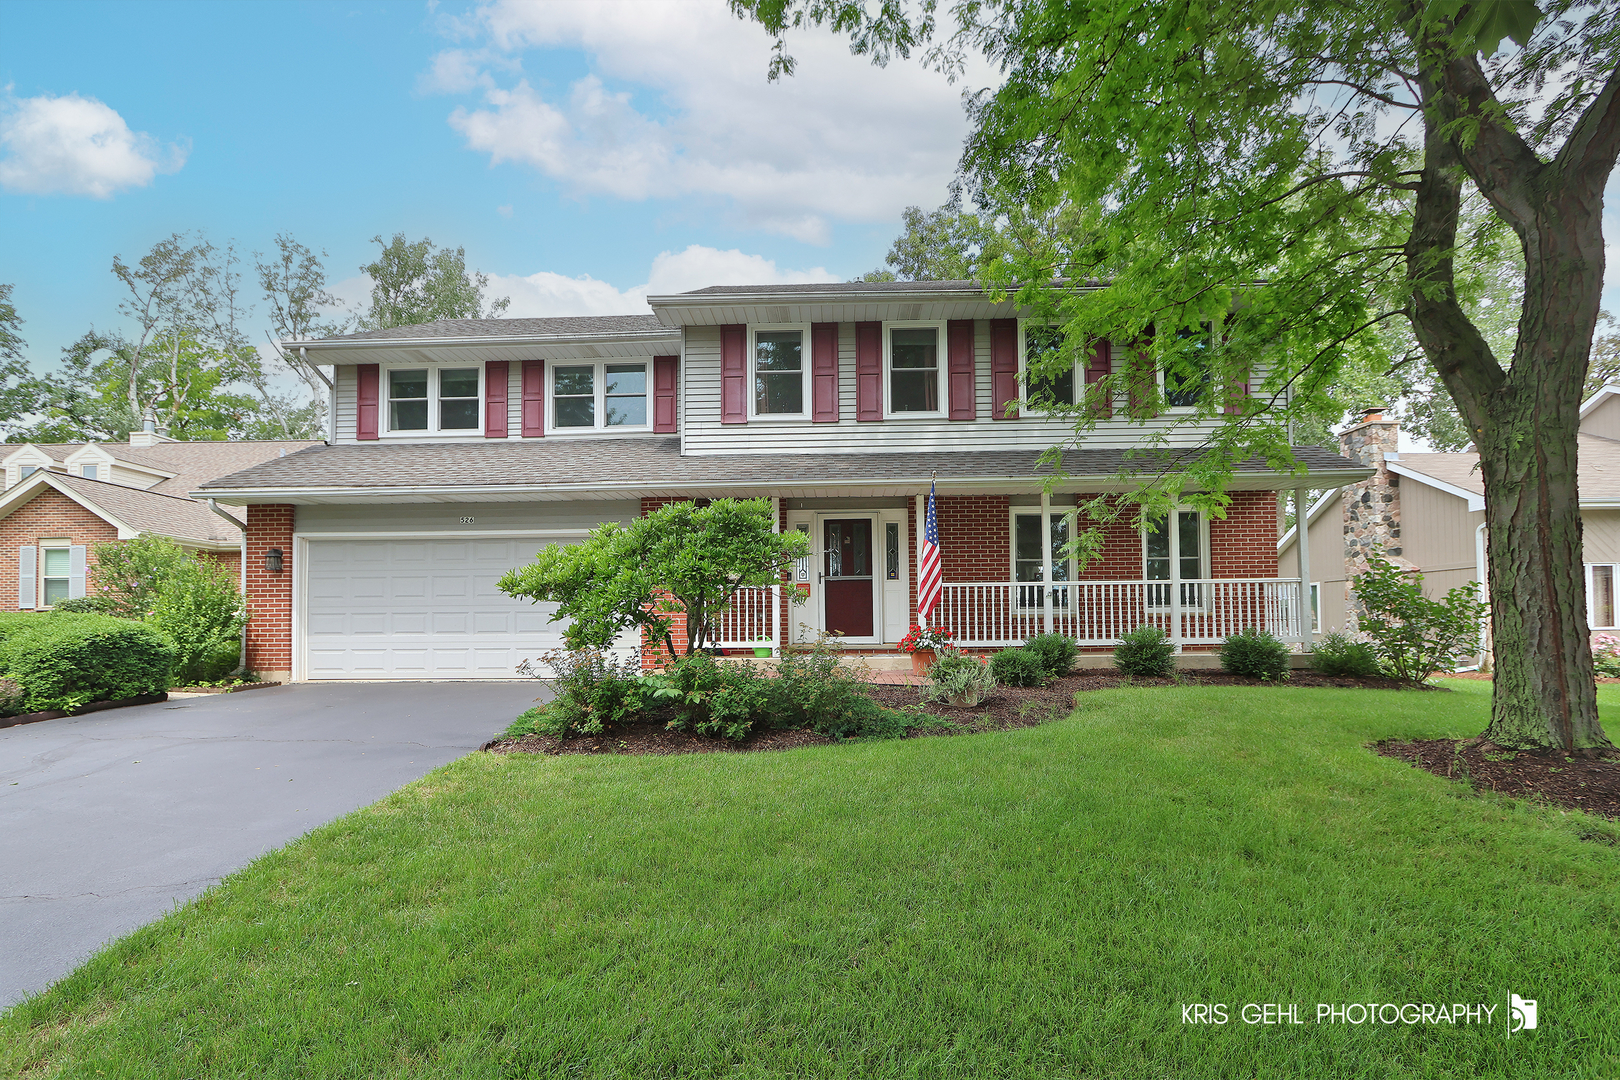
[{"x1": 199, "y1": 282, "x2": 1367, "y2": 680}]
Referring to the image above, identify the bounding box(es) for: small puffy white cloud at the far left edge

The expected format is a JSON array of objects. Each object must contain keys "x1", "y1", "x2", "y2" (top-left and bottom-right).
[{"x1": 0, "y1": 94, "x2": 188, "y2": 199}]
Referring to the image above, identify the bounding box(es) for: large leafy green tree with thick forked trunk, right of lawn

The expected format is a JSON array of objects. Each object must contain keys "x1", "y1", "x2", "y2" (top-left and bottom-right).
[{"x1": 732, "y1": 0, "x2": 1620, "y2": 750}]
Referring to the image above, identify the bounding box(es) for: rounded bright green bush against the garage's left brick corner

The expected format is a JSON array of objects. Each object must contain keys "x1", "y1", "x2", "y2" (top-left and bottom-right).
[{"x1": 146, "y1": 557, "x2": 248, "y2": 687}]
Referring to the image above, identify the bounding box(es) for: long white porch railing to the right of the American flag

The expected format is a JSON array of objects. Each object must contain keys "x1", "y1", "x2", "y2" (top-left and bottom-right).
[{"x1": 930, "y1": 578, "x2": 1301, "y2": 648}]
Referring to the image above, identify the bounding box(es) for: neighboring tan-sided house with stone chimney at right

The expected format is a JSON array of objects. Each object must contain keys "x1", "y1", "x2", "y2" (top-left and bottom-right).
[{"x1": 1277, "y1": 387, "x2": 1620, "y2": 650}]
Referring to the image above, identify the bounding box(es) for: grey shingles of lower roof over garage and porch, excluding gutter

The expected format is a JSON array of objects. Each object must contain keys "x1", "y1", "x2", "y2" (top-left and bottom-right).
[{"x1": 203, "y1": 437, "x2": 1367, "y2": 494}]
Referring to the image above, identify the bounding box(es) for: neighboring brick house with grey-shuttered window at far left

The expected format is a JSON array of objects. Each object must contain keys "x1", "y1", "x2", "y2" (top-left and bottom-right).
[{"x1": 0, "y1": 432, "x2": 316, "y2": 610}]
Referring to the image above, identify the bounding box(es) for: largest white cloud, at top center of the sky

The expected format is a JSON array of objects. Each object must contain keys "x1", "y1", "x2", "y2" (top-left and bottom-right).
[{"x1": 434, "y1": 0, "x2": 988, "y2": 243}]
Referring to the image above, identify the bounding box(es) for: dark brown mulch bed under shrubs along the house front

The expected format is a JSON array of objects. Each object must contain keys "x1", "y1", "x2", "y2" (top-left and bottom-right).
[{"x1": 481, "y1": 670, "x2": 1401, "y2": 755}]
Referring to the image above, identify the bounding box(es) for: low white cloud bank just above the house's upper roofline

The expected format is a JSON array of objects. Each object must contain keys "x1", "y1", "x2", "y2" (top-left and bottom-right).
[{"x1": 479, "y1": 244, "x2": 839, "y2": 319}]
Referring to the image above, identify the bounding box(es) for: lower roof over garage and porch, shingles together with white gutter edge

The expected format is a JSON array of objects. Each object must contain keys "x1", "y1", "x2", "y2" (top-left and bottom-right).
[{"x1": 196, "y1": 437, "x2": 1371, "y2": 505}]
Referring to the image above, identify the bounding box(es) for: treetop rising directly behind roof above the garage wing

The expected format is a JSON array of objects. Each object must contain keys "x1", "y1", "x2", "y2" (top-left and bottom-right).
[{"x1": 360, "y1": 233, "x2": 512, "y2": 330}]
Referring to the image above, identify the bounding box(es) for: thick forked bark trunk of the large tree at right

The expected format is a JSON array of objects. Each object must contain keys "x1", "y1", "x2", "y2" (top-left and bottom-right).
[{"x1": 1408, "y1": 58, "x2": 1615, "y2": 751}]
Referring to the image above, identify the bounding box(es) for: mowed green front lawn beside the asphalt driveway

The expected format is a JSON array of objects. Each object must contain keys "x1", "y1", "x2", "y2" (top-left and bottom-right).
[{"x1": 9, "y1": 683, "x2": 1620, "y2": 1080}]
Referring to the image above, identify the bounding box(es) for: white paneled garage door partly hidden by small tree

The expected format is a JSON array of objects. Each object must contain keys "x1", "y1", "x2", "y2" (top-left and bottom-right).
[{"x1": 305, "y1": 538, "x2": 579, "y2": 678}]
